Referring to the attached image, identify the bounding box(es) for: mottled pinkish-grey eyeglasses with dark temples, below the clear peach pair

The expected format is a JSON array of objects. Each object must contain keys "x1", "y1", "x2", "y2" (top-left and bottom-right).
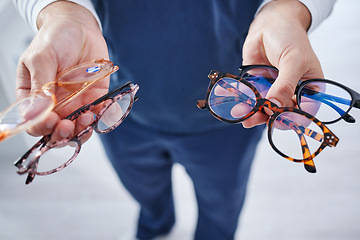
[{"x1": 15, "y1": 82, "x2": 139, "y2": 184}]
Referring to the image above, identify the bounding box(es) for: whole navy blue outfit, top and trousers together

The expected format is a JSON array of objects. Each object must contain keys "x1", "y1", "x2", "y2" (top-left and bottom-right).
[{"x1": 93, "y1": 0, "x2": 263, "y2": 240}]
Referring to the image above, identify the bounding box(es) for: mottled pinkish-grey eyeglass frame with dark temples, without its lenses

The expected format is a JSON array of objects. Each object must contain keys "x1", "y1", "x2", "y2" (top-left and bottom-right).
[{"x1": 14, "y1": 82, "x2": 139, "y2": 184}]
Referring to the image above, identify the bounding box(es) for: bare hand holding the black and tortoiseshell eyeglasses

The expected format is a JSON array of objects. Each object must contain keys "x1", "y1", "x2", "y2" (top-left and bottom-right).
[{"x1": 243, "y1": 0, "x2": 323, "y2": 128}]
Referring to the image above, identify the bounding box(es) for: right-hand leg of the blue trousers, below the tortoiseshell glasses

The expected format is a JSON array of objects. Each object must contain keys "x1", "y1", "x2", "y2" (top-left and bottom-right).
[{"x1": 170, "y1": 125, "x2": 262, "y2": 240}]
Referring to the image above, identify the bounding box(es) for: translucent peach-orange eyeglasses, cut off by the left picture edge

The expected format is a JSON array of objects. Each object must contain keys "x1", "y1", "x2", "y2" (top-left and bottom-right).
[{"x1": 0, "y1": 59, "x2": 118, "y2": 142}]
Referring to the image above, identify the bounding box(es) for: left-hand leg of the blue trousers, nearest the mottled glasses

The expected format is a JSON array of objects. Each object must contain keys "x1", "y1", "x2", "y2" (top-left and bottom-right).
[{"x1": 101, "y1": 121, "x2": 175, "y2": 239}]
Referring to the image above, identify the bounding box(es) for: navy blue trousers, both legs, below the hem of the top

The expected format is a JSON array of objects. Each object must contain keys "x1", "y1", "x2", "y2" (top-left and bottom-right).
[{"x1": 101, "y1": 118, "x2": 263, "y2": 240}]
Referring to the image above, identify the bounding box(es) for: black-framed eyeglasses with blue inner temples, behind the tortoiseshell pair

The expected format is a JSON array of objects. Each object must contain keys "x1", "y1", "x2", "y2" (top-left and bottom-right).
[{"x1": 239, "y1": 65, "x2": 360, "y2": 124}]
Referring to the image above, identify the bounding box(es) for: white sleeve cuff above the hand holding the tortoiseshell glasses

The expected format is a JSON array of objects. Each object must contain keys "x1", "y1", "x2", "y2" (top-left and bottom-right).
[{"x1": 256, "y1": 0, "x2": 336, "y2": 32}]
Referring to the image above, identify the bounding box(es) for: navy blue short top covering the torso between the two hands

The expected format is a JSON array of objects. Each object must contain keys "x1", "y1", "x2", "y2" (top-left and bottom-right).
[{"x1": 93, "y1": 0, "x2": 262, "y2": 133}]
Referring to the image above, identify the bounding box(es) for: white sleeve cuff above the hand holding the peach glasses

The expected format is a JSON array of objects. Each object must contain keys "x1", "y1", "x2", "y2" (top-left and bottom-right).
[{"x1": 13, "y1": 0, "x2": 102, "y2": 32}]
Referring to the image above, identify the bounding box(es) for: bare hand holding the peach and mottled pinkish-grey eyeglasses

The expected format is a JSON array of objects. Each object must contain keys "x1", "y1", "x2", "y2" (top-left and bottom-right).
[{"x1": 16, "y1": 1, "x2": 109, "y2": 141}]
